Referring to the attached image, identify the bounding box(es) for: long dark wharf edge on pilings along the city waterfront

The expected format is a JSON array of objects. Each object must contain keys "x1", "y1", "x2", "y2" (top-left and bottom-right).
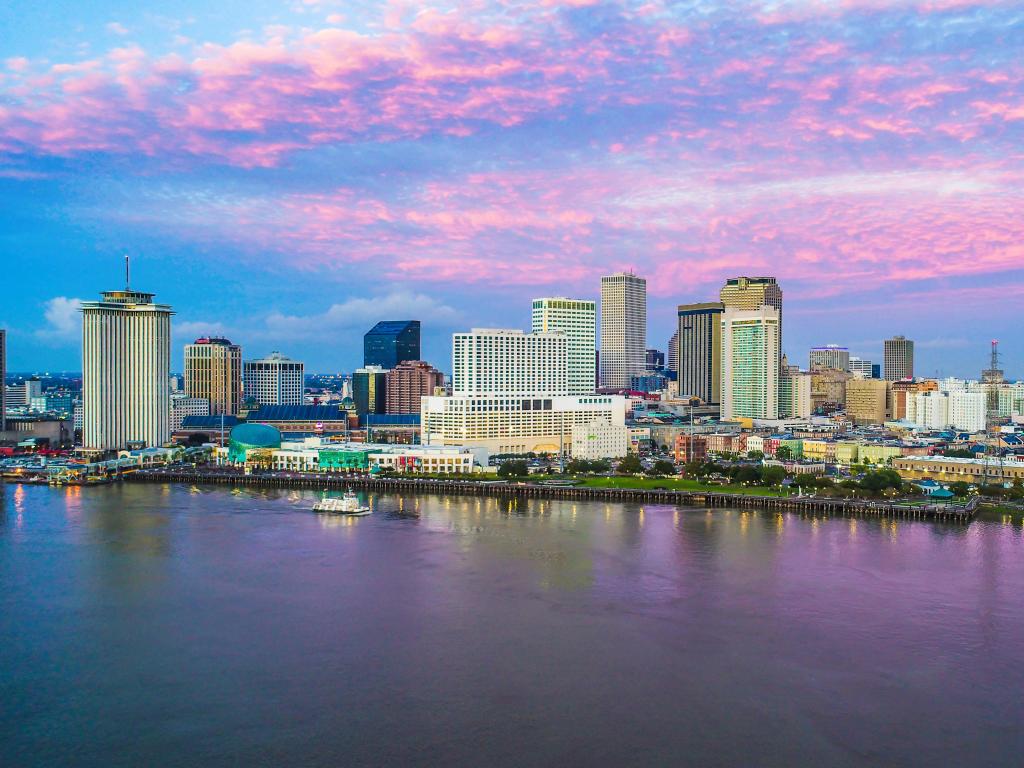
[{"x1": 125, "y1": 468, "x2": 978, "y2": 524}]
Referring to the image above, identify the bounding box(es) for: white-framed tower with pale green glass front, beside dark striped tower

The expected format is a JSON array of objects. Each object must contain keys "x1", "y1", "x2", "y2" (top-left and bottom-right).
[{"x1": 722, "y1": 304, "x2": 780, "y2": 419}]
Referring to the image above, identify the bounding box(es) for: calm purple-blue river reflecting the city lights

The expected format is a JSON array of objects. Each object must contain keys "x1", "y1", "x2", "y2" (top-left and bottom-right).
[{"x1": 0, "y1": 484, "x2": 1024, "y2": 768}]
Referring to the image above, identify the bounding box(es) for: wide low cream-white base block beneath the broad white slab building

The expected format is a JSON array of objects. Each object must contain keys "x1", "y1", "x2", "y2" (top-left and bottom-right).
[{"x1": 420, "y1": 394, "x2": 626, "y2": 454}]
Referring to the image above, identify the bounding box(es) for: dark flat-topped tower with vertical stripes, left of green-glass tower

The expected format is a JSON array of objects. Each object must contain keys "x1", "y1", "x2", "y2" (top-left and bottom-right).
[{"x1": 676, "y1": 302, "x2": 725, "y2": 404}]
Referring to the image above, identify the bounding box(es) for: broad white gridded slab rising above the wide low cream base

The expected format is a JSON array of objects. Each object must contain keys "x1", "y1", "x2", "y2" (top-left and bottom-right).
[{"x1": 452, "y1": 328, "x2": 568, "y2": 397}]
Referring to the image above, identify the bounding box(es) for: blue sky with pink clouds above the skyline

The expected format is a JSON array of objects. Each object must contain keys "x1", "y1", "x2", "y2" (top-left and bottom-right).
[{"x1": 0, "y1": 0, "x2": 1024, "y2": 378}]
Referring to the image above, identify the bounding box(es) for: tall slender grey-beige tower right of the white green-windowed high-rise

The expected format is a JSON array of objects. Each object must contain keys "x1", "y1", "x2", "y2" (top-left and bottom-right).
[{"x1": 600, "y1": 272, "x2": 647, "y2": 388}]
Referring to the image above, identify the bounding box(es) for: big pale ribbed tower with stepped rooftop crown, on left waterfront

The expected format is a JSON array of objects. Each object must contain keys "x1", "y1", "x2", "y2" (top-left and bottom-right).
[{"x1": 82, "y1": 286, "x2": 173, "y2": 452}]
